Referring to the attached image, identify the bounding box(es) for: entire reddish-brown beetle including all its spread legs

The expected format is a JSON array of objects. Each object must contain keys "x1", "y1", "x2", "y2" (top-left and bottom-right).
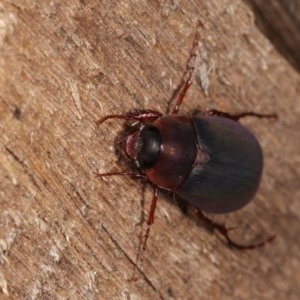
[{"x1": 95, "y1": 22, "x2": 277, "y2": 279}]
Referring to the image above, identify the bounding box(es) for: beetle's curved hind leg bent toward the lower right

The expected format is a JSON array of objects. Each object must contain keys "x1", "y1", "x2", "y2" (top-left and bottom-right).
[{"x1": 194, "y1": 209, "x2": 276, "y2": 250}]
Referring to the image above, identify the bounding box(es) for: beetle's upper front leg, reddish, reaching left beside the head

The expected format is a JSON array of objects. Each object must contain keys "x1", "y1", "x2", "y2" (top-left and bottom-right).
[{"x1": 96, "y1": 109, "x2": 162, "y2": 126}]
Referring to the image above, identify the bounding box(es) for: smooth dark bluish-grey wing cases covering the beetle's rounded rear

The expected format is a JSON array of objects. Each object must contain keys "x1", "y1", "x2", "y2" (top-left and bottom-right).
[{"x1": 177, "y1": 116, "x2": 263, "y2": 213}]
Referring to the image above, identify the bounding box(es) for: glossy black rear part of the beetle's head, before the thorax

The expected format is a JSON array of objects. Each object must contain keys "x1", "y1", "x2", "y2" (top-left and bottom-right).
[{"x1": 137, "y1": 126, "x2": 161, "y2": 169}]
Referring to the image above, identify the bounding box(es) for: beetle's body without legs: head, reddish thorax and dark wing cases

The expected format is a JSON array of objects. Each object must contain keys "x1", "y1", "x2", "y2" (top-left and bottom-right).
[{"x1": 126, "y1": 115, "x2": 263, "y2": 213}]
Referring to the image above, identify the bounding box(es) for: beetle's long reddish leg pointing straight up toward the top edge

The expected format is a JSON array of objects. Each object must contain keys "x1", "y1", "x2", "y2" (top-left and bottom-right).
[{"x1": 172, "y1": 20, "x2": 204, "y2": 115}]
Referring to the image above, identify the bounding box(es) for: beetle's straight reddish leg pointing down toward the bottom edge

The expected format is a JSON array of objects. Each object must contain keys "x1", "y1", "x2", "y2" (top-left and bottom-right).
[{"x1": 132, "y1": 186, "x2": 158, "y2": 281}]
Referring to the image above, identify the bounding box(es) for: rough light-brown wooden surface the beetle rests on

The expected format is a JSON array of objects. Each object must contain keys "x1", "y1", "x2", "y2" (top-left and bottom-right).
[{"x1": 0, "y1": 0, "x2": 300, "y2": 300}]
